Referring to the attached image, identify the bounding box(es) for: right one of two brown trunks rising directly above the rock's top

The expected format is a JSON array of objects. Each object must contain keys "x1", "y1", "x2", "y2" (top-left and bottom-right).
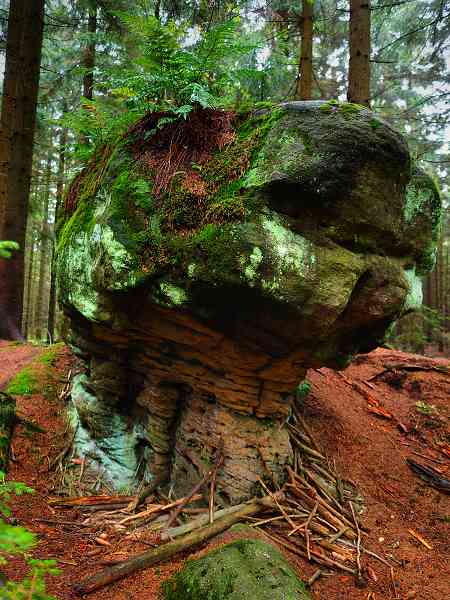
[{"x1": 347, "y1": 0, "x2": 370, "y2": 106}]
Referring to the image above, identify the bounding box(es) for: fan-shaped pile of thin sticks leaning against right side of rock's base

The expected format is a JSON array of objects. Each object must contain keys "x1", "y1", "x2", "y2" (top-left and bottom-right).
[{"x1": 252, "y1": 407, "x2": 380, "y2": 578}]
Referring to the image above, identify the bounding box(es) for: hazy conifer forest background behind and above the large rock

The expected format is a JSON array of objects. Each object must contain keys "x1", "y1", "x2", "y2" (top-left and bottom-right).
[{"x1": 0, "y1": 0, "x2": 450, "y2": 354}]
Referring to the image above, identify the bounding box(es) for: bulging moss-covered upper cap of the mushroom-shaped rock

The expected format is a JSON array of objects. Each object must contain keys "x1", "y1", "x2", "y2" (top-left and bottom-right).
[{"x1": 57, "y1": 102, "x2": 441, "y2": 368}]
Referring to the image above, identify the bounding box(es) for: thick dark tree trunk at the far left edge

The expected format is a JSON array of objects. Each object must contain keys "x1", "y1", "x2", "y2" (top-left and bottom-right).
[{"x1": 0, "y1": 0, "x2": 44, "y2": 339}]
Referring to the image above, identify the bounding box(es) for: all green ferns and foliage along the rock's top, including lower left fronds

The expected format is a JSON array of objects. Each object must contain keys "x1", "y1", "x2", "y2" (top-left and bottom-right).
[{"x1": 65, "y1": 13, "x2": 254, "y2": 161}]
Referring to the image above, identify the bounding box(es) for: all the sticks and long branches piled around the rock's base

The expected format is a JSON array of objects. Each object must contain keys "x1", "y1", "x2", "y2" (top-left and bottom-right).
[{"x1": 51, "y1": 400, "x2": 392, "y2": 594}]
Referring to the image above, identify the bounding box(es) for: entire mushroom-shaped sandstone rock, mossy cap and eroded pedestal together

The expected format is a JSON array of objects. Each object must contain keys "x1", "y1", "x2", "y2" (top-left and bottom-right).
[{"x1": 57, "y1": 103, "x2": 440, "y2": 502}]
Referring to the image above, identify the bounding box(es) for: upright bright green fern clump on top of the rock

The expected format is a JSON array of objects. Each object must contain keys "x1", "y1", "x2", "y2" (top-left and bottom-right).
[{"x1": 113, "y1": 15, "x2": 254, "y2": 118}]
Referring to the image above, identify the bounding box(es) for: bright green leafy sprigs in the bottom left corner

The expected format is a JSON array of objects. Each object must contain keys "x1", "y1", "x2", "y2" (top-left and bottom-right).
[{"x1": 0, "y1": 471, "x2": 59, "y2": 600}]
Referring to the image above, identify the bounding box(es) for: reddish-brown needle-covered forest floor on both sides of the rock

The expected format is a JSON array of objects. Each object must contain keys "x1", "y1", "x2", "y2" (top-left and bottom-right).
[{"x1": 0, "y1": 342, "x2": 450, "y2": 600}]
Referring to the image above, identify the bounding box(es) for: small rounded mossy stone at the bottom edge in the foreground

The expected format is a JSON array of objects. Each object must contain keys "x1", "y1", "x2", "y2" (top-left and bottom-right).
[{"x1": 164, "y1": 539, "x2": 311, "y2": 600}]
